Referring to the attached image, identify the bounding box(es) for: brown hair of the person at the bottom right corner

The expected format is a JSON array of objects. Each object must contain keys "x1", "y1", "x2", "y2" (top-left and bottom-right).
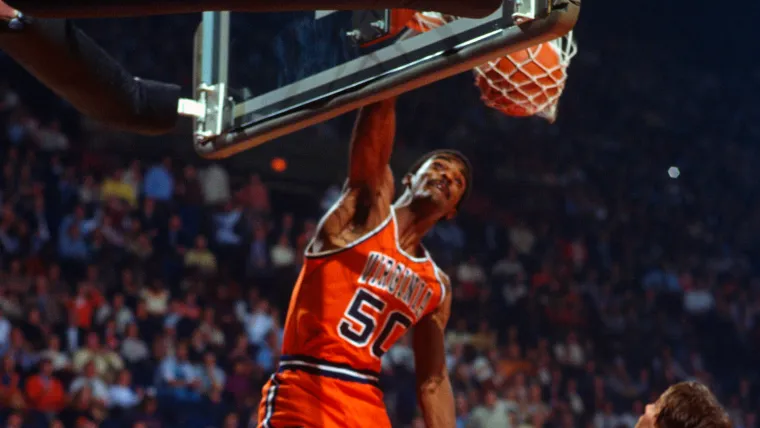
[{"x1": 655, "y1": 382, "x2": 731, "y2": 428}]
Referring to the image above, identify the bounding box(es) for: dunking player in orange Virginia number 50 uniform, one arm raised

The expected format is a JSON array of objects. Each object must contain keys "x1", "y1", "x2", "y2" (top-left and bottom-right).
[{"x1": 259, "y1": 100, "x2": 470, "y2": 428}]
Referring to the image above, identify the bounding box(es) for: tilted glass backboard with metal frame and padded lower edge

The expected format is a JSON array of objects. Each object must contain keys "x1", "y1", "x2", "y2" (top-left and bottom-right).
[{"x1": 187, "y1": 0, "x2": 580, "y2": 159}]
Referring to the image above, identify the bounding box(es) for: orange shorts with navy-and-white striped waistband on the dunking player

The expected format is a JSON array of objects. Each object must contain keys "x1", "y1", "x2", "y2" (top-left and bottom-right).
[{"x1": 259, "y1": 357, "x2": 391, "y2": 428}]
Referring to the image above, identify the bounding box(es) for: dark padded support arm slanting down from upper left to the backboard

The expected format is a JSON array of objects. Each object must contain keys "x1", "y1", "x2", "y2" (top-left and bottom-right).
[{"x1": 0, "y1": 0, "x2": 180, "y2": 135}]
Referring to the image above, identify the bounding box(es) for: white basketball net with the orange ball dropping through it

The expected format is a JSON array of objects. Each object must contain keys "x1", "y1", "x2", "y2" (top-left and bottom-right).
[{"x1": 408, "y1": 12, "x2": 578, "y2": 122}]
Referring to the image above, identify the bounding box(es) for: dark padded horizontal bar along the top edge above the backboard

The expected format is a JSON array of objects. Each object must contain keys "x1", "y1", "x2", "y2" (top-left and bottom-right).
[{"x1": 6, "y1": 0, "x2": 502, "y2": 18}]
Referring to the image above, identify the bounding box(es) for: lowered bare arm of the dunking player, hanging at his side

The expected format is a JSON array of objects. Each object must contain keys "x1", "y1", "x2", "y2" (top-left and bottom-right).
[{"x1": 413, "y1": 281, "x2": 456, "y2": 428}]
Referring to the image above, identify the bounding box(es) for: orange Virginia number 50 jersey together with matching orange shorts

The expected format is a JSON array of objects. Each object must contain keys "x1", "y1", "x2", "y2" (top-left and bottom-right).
[{"x1": 259, "y1": 209, "x2": 446, "y2": 428}]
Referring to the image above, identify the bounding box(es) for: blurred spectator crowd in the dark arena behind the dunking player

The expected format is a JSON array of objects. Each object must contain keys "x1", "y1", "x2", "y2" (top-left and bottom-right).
[{"x1": 0, "y1": 3, "x2": 760, "y2": 428}]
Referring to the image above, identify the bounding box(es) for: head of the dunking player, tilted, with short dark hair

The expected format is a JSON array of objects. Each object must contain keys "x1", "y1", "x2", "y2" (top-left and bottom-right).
[{"x1": 409, "y1": 155, "x2": 467, "y2": 217}]
